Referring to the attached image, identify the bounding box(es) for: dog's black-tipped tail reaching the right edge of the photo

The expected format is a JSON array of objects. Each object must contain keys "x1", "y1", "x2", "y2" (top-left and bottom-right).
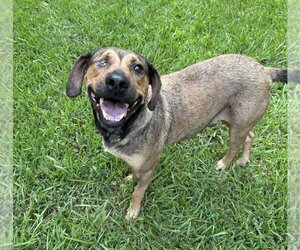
[{"x1": 268, "y1": 68, "x2": 300, "y2": 83}]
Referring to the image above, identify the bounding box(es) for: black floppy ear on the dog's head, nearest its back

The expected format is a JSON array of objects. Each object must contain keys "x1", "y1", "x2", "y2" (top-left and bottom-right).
[{"x1": 147, "y1": 62, "x2": 161, "y2": 111}]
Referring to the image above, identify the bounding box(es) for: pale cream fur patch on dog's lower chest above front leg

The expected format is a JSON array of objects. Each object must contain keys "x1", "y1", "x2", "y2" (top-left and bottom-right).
[{"x1": 104, "y1": 147, "x2": 145, "y2": 171}]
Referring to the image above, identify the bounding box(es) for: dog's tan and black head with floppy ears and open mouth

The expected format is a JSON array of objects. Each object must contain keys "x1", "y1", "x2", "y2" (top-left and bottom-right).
[{"x1": 67, "y1": 48, "x2": 161, "y2": 127}]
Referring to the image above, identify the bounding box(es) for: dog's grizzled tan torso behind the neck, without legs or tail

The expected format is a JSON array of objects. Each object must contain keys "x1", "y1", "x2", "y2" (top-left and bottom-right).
[{"x1": 162, "y1": 54, "x2": 272, "y2": 143}]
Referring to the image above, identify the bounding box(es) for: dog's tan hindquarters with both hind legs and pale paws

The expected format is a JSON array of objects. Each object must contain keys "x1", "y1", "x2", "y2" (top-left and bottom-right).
[{"x1": 216, "y1": 84, "x2": 269, "y2": 171}]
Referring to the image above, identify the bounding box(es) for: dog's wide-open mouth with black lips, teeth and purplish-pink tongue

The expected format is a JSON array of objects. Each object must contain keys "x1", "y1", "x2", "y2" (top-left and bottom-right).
[{"x1": 90, "y1": 92, "x2": 140, "y2": 125}]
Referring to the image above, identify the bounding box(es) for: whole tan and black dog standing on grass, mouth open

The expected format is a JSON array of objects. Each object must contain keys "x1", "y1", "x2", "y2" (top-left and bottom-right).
[{"x1": 66, "y1": 47, "x2": 300, "y2": 219}]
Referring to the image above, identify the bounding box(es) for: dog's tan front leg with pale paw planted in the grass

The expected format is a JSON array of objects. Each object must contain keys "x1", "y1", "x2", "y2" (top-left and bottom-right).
[{"x1": 125, "y1": 161, "x2": 156, "y2": 220}]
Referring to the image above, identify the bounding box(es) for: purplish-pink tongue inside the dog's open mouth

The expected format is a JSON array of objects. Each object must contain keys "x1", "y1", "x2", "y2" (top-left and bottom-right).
[{"x1": 101, "y1": 100, "x2": 127, "y2": 121}]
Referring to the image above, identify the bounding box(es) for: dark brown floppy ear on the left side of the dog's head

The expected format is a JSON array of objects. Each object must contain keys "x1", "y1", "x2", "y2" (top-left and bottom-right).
[{"x1": 66, "y1": 53, "x2": 93, "y2": 97}]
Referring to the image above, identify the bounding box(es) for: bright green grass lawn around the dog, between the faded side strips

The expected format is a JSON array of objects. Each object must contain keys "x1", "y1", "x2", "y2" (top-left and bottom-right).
[{"x1": 14, "y1": 0, "x2": 287, "y2": 250}]
